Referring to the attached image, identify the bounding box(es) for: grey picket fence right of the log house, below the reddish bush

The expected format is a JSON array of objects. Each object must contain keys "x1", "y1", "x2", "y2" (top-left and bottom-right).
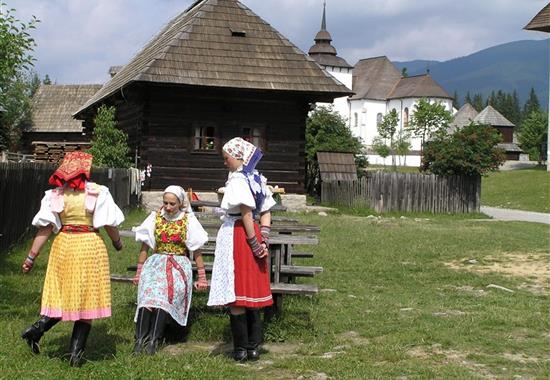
[{"x1": 321, "y1": 172, "x2": 481, "y2": 213}]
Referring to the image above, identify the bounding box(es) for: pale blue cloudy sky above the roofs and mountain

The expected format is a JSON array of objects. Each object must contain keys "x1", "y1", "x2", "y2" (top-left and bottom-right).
[{"x1": 5, "y1": 0, "x2": 548, "y2": 84}]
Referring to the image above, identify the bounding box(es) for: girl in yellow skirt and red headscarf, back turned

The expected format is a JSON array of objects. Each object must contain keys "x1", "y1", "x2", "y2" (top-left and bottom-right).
[{"x1": 21, "y1": 152, "x2": 124, "y2": 366}]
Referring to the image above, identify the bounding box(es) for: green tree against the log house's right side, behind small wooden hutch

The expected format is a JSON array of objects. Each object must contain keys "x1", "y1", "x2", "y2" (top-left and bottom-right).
[{"x1": 306, "y1": 107, "x2": 366, "y2": 194}]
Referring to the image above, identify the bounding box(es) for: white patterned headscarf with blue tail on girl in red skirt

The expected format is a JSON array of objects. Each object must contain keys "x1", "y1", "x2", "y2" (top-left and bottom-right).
[{"x1": 223, "y1": 137, "x2": 267, "y2": 214}]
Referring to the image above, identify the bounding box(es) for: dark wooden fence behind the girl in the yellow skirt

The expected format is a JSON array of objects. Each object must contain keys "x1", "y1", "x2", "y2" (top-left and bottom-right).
[{"x1": 0, "y1": 162, "x2": 138, "y2": 254}]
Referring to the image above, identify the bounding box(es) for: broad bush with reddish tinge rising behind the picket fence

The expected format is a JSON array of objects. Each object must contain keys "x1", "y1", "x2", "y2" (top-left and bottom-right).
[{"x1": 421, "y1": 123, "x2": 505, "y2": 176}]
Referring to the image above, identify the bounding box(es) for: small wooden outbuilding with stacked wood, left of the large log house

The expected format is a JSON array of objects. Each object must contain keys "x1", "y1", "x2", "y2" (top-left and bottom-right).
[{"x1": 22, "y1": 84, "x2": 101, "y2": 162}]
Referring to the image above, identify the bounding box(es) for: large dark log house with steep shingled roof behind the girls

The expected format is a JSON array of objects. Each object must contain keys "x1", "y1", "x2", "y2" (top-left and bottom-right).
[{"x1": 75, "y1": 0, "x2": 350, "y2": 193}]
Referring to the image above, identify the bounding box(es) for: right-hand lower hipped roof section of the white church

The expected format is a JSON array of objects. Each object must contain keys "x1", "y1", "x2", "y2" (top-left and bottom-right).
[{"x1": 388, "y1": 74, "x2": 453, "y2": 99}]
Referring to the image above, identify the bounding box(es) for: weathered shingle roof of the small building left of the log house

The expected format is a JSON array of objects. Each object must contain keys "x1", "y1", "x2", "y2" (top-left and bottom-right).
[{"x1": 29, "y1": 84, "x2": 101, "y2": 132}]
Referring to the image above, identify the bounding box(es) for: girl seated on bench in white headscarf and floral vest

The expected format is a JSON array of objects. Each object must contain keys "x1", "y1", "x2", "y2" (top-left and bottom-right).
[{"x1": 134, "y1": 186, "x2": 208, "y2": 355}]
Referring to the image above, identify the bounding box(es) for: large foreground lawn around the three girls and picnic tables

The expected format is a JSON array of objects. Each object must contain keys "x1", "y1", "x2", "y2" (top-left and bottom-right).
[{"x1": 0, "y1": 209, "x2": 550, "y2": 379}]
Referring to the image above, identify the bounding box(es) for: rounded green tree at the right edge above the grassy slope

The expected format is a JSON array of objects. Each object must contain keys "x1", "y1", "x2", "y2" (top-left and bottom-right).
[{"x1": 518, "y1": 111, "x2": 548, "y2": 164}]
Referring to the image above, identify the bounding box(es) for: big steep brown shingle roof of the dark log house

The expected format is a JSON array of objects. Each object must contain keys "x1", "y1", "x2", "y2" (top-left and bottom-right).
[{"x1": 77, "y1": 0, "x2": 350, "y2": 114}]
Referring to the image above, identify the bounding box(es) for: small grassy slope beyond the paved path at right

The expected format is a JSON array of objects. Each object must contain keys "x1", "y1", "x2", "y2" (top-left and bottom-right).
[{"x1": 481, "y1": 167, "x2": 550, "y2": 213}]
